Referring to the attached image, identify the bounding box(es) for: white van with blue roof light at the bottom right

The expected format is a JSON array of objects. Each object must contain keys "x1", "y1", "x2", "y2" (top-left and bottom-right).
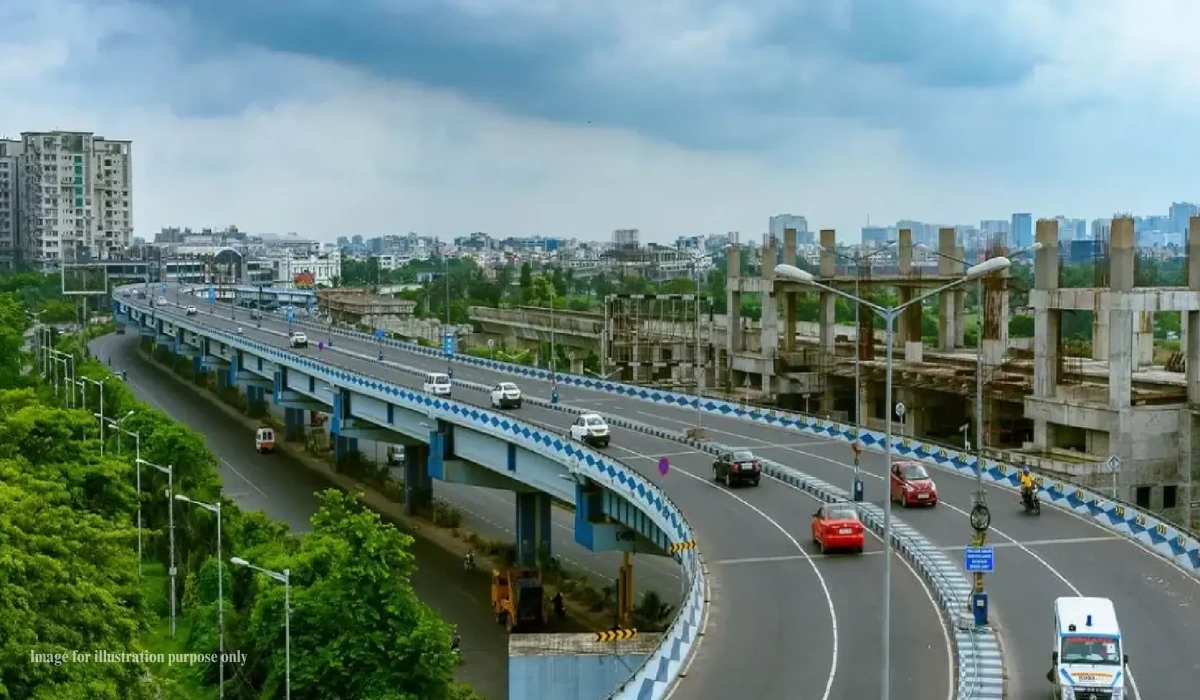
[{"x1": 1048, "y1": 598, "x2": 1129, "y2": 700}]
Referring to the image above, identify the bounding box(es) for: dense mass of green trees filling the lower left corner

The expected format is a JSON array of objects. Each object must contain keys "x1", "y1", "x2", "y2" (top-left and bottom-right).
[{"x1": 0, "y1": 279, "x2": 475, "y2": 700}]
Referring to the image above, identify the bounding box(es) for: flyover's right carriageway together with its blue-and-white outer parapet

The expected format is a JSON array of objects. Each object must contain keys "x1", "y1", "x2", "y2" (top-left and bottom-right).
[{"x1": 270, "y1": 295, "x2": 1200, "y2": 699}]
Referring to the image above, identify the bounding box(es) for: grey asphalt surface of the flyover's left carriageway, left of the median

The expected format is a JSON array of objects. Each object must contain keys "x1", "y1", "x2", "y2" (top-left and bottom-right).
[{"x1": 147, "y1": 295, "x2": 955, "y2": 700}]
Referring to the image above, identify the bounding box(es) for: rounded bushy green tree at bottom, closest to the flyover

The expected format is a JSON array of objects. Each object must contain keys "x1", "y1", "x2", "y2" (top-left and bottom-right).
[{"x1": 242, "y1": 490, "x2": 462, "y2": 700}]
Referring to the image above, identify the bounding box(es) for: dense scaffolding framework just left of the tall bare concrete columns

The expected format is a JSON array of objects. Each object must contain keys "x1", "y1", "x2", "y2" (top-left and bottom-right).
[{"x1": 600, "y1": 294, "x2": 713, "y2": 385}]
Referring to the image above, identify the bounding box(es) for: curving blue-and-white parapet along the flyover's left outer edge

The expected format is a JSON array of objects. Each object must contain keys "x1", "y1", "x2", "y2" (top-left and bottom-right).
[{"x1": 114, "y1": 291, "x2": 708, "y2": 700}]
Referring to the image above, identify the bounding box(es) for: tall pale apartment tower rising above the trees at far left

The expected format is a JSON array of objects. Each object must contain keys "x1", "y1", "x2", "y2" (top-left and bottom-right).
[{"x1": 17, "y1": 131, "x2": 133, "y2": 269}]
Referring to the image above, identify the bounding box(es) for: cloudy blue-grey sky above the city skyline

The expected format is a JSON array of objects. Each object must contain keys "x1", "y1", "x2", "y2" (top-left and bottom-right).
[{"x1": 0, "y1": 0, "x2": 1200, "y2": 243}]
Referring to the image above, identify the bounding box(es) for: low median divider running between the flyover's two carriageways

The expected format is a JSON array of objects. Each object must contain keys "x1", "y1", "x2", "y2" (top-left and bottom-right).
[{"x1": 236, "y1": 319, "x2": 1004, "y2": 700}]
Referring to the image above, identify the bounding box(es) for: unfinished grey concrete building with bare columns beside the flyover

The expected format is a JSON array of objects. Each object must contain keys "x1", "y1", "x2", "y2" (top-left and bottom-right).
[{"x1": 472, "y1": 222, "x2": 1200, "y2": 526}]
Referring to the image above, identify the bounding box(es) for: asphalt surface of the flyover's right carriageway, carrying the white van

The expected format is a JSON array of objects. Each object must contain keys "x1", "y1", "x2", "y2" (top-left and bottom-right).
[{"x1": 243, "y1": 309, "x2": 1200, "y2": 700}]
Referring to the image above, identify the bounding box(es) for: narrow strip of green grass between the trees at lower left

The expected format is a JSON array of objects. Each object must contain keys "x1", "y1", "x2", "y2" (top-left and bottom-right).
[{"x1": 142, "y1": 562, "x2": 217, "y2": 700}]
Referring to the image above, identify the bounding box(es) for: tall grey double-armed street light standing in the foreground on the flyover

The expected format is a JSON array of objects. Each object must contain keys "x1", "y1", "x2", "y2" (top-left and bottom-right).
[{"x1": 775, "y1": 257, "x2": 1012, "y2": 700}]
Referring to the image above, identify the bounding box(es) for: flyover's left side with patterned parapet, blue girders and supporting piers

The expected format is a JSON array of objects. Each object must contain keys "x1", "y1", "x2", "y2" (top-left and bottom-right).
[{"x1": 114, "y1": 284, "x2": 707, "y2": 699}]
